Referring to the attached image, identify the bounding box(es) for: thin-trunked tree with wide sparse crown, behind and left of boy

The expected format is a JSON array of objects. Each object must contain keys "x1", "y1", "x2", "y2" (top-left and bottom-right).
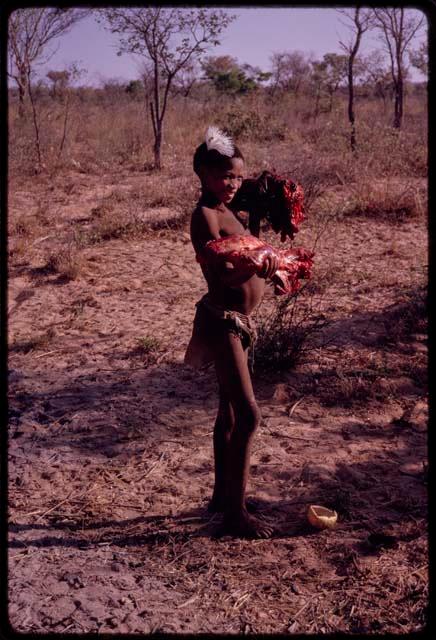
[{"x1": 98, "y1": 7, "x2": 234, "y2": 169}]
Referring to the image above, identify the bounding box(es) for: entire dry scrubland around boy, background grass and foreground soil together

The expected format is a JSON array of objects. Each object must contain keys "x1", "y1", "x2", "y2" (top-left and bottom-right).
[{"x1": 7, "y1": 89, "x2": 428, "y2": 634}]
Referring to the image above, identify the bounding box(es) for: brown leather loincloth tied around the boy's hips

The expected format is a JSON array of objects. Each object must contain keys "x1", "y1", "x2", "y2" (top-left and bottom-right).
[{"x1": 184, "y1": 294, "x2": 257, "y2": 369}]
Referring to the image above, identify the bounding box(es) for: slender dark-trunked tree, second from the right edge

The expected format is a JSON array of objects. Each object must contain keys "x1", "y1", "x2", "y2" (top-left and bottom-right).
[{"x1": 338, "y1": 6, "x2": 372, "y2": 153}]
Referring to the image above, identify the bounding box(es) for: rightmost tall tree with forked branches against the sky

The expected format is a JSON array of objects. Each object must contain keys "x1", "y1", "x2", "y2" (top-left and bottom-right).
[{"x1": 373, "y1": 7, "x2": 425, "y2": 129}]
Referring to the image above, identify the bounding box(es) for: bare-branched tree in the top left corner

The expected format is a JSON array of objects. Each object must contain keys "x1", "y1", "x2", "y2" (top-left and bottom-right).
[{"x1": 8, "y1": 8, "x2": 89, "y2": 116}]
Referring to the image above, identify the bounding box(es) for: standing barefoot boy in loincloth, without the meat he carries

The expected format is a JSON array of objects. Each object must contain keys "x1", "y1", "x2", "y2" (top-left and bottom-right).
[{"x1": 185, "y1": 127, "x2": 278, "y2": 537}]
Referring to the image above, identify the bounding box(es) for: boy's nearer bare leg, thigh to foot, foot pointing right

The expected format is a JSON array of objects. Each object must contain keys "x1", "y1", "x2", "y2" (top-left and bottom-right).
[{"x1": 211, "y1": 332, "x2": 272, "y2": 537}]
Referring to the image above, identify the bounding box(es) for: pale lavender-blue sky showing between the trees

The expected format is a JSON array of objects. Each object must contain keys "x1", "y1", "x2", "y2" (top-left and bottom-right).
[{"x1": 25, "y1": 7, "x2": 426, "y2": 85}]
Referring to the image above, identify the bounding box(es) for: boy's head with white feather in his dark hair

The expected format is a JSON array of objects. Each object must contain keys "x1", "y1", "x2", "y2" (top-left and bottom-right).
[{"x1": 193, "y1": 127, "x2": 244, "y2": 202}]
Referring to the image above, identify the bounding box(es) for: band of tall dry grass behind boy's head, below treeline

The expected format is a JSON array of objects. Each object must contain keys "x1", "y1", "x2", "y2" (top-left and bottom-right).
[{"x1": 9, "y1": 89, "x2": 427, "y2": 181}]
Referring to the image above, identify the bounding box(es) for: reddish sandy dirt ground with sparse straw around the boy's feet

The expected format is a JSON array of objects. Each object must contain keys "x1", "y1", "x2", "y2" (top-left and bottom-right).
[{"x1": 8, "y1": 173, "x2": 427, "y2": 634}]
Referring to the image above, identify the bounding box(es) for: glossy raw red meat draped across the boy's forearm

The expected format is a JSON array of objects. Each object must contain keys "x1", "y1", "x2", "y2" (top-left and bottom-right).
[{"x1": 197, "y1": 235, "x2": 314, "y2": 295}]
